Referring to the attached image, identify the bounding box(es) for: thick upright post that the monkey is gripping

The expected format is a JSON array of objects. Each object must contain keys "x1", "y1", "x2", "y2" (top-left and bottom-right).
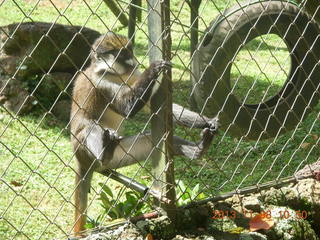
[{"x1": 148, "y1": 0, "x2": 176, "y2": 223}]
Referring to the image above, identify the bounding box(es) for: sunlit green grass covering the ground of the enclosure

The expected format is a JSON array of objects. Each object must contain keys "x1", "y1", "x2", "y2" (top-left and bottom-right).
[{"x1": 0, "y1": 0, "x2": 319, "y2": 239}]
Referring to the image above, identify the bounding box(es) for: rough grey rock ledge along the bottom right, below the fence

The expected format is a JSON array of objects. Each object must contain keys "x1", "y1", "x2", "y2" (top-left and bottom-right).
[{"x1": 79, "y1": 171, "x2": 320, "y2": 240}]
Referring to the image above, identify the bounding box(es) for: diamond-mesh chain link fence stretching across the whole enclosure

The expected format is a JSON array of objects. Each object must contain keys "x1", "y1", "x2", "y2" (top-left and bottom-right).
[{"x1": 0, "y1": 0, "x2": 320, "y2": 239}]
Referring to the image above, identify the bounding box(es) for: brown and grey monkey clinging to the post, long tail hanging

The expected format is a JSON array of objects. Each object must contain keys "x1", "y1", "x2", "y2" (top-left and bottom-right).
[{"x1": 70, "y1": 32, "x2": 218, "y2": 235}]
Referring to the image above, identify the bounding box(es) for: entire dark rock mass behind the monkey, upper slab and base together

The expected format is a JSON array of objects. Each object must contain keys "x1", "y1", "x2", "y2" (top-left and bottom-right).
[{"x1": 0, "y1": 22, "x2": 100, "y2": 116}]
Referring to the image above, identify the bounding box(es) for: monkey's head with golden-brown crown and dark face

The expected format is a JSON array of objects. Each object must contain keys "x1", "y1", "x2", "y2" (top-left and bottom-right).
[{"x1": 92, "y1": 33, "x2": 137, "y2": 75}]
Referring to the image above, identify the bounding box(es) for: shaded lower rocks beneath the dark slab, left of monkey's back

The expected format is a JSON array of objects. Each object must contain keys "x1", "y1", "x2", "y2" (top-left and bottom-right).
[{"x1": 0, "y1": 72, "x2": 73, "y2": 115}]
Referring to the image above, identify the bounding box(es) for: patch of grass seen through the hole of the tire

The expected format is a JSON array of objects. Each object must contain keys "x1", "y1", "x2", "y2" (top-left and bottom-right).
[{"x1": 231, "y1": 34, "x2": 290, "y2": 104}]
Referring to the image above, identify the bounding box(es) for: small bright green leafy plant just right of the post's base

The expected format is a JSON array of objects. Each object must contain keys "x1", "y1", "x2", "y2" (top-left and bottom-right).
[{"x1": 176, "y1": 180, "x2": 205, "y2": 206}]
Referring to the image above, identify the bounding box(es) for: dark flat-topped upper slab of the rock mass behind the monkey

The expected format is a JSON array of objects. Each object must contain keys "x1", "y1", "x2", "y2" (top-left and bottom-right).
[{"x1": 0, "y1": 22, "x2": 100, "y2": 77}]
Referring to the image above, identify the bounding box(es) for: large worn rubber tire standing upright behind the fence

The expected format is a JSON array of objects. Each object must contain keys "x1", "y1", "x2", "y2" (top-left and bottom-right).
[{"x1": 192, "y1": 1, "x2": 320, "y2": 140}]
